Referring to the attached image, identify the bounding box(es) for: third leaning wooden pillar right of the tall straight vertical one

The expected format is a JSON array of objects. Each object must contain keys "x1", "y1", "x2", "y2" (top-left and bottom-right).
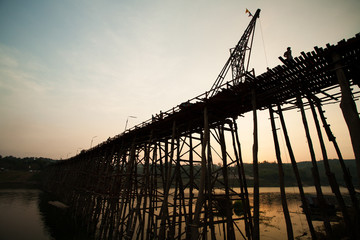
[{"x1": 296, "y1": 95, "x2": 333, "y2": 238}]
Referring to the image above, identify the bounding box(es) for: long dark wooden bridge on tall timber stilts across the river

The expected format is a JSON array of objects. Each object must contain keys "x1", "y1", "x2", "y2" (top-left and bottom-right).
[{"x1": 44, "y1": 10, "x2": 360, "y2": 239}]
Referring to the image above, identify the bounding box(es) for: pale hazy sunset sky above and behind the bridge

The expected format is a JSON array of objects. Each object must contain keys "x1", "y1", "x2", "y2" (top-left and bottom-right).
[{"x1": 0, "y1": 0, "x2": 360, "y2": 161}]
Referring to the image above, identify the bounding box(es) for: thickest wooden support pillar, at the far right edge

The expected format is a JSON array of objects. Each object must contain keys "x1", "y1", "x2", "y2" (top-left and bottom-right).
[{"x1": 332, "y1": 53, "x2": 360, "y2": 186}]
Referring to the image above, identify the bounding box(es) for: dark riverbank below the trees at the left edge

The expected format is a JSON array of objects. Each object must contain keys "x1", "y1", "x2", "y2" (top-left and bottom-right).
[{"x1": 0, "y1": 170, "x2": 41, "y2": 189}]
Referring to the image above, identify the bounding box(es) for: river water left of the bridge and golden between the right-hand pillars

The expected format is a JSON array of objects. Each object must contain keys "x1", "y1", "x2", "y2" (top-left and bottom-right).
[{"x1": 0, "y1": 187, "x2": 346, "y2": 240}]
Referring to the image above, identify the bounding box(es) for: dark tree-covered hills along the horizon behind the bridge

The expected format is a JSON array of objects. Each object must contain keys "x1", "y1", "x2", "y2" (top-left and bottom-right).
[{"x1": 0, "y1": 155, "x2": 358, "y2": 187}]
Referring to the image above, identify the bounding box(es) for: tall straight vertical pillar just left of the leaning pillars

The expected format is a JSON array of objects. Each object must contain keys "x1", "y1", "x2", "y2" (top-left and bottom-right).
[{"x1": 251, "y1": 89, "x2": 260, "y2": 240}]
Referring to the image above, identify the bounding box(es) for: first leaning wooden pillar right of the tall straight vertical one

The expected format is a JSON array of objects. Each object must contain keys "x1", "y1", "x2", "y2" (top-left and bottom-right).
[{"x1": 269, "y1": 106, "x2": 294, "y2": 239}]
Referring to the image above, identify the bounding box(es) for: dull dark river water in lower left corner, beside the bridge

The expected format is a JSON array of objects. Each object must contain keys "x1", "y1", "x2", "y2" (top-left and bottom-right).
[{"x1": 0, "y1": 189, "x2": 91, "y2": 240}]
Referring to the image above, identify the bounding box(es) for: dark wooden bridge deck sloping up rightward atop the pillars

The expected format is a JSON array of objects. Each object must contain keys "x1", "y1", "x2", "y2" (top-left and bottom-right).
[{"x1": 80, "y1": 34, "x2": 360, "y2": 153}]
